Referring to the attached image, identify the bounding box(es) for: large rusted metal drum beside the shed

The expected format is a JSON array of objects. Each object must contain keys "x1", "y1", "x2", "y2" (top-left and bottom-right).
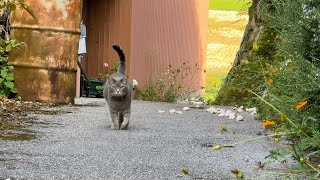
[{"x1": 9, "y1": 0, "x2": 82, "y2": 103}]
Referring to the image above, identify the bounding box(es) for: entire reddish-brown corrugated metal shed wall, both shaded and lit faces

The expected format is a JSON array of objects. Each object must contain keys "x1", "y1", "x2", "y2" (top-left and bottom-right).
[{"x1": 85, "y1": 0, "x2": 209, "y2": 92}]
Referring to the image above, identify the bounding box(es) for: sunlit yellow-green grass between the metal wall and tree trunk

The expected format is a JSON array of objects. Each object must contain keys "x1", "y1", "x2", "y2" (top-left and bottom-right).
[{"x1": 204, "y1": 5, "x2": 251, "y2": 103}]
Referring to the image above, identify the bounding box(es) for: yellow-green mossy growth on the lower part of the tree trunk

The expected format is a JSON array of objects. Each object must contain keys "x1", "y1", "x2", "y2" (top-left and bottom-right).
[{"x1": 215, "y1": 30, "x2": 276, "y2": 105}]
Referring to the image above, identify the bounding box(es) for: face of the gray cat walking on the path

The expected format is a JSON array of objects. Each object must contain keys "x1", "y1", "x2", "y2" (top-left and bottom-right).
[{"x1": 108, "y1": 77, "x2": 129, "y2": 97}]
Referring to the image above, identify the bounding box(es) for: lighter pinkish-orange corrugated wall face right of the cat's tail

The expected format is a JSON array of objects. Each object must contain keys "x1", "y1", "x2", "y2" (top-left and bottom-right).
[{"x1": 130, "y1": 0, "x2": 209, "y2": 92}]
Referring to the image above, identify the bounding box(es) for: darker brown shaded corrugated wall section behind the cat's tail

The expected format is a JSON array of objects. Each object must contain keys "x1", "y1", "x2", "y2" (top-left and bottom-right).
[{"x1": 84, "y1": 0, "x2": 132, "y2": 77}]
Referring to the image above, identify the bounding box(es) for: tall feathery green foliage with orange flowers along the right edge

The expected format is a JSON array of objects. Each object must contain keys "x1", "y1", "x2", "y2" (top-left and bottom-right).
[{"x1": 250, "y1": 0, "x2": 320, "y2": 178}]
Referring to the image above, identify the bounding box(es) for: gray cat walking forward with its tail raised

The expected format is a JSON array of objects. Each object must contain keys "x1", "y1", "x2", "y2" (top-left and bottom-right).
[{"x1": 103, "y1": 44, "x2": 132, "y2": 129}]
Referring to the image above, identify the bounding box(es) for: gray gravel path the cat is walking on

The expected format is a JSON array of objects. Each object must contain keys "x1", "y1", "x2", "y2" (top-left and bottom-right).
[{"x1": 0, "y1": 100, "x2": 276, "y2": 180}]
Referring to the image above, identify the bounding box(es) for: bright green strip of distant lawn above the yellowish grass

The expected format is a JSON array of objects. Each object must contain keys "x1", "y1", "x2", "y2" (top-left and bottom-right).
[{"x1": 209, "y1": 0, "x2": 252, "y2": 11}]
